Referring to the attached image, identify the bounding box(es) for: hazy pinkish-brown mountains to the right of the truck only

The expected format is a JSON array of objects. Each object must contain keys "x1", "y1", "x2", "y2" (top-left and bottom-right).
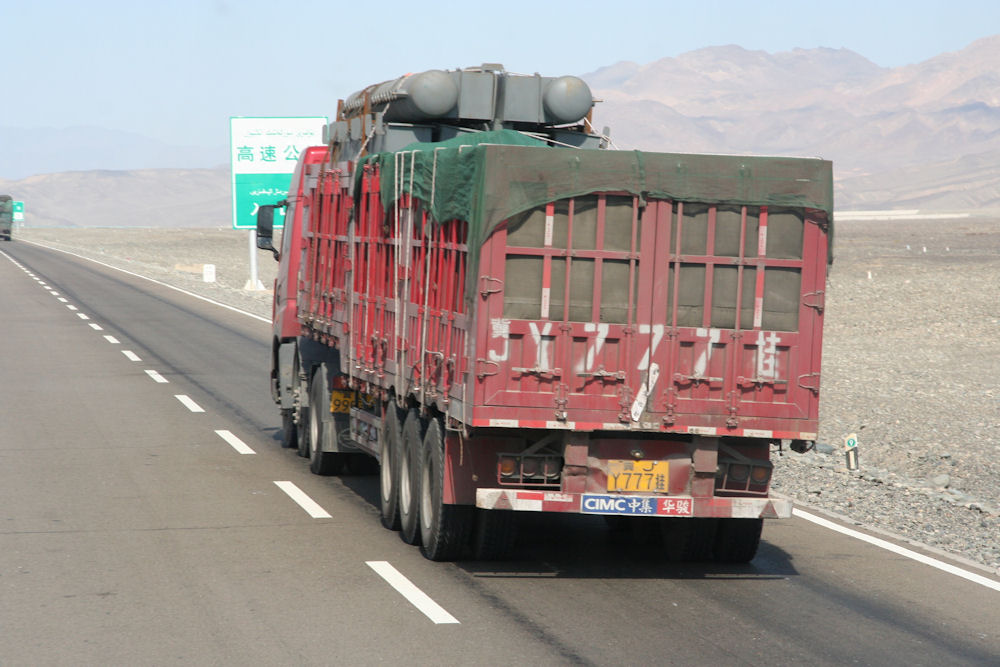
[{"x1": 583, "y1": 35, "x2": 1000, "y2": 209}]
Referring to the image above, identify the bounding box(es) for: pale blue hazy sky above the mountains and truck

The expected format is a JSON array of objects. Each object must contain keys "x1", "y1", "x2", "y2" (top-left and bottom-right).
[{"x1": 0, "y1": 0, "x2": 1000, "y2": 146}]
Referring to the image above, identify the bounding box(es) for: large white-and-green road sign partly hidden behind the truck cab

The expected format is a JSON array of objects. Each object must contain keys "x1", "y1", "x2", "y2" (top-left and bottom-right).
[{"x1": 229, "y1": 116, "x2": 327, "y2": 229}]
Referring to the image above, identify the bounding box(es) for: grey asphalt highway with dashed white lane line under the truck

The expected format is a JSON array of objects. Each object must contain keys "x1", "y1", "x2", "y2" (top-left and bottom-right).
[{"x1": 0, "y1": 242, "x2": 1000, "y2": 666}]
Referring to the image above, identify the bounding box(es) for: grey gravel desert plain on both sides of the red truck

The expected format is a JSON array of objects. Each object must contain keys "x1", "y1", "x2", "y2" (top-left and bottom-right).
[{"x1": 15, "y1": 218, "x2": 1000, "y2": 571}]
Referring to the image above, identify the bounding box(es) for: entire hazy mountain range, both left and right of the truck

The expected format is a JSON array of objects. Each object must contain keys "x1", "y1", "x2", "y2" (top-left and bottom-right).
[{"x1": 0, "y1": 35, "x2": 1000, "y2": 226}]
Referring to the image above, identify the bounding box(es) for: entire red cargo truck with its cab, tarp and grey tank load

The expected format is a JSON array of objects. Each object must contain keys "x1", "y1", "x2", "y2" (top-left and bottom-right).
[{"x1": 257, "y1": 65, "x2": 833, "y2": 562}]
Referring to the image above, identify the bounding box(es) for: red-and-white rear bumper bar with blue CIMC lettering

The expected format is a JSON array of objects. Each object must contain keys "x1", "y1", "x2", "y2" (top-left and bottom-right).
[{"x1": 476, "y1": 489, "x2": 792, "y2": 519}]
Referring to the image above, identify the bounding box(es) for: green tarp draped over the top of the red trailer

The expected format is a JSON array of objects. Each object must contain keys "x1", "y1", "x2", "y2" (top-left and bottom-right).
[{"x1": 355, "y1": 130, "x2": 833, "y2": 306}]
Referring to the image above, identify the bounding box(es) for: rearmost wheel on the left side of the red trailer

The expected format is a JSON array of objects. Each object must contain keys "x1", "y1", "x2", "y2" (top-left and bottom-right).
[{"x1": 419, "y1": 419, "x2": 474, "y2": 561}]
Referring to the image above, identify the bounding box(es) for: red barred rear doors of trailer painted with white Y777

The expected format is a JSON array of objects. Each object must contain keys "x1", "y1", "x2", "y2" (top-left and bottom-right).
[{"x1": 477, "y1": 194, "x2": 827, "y2": 431}]
